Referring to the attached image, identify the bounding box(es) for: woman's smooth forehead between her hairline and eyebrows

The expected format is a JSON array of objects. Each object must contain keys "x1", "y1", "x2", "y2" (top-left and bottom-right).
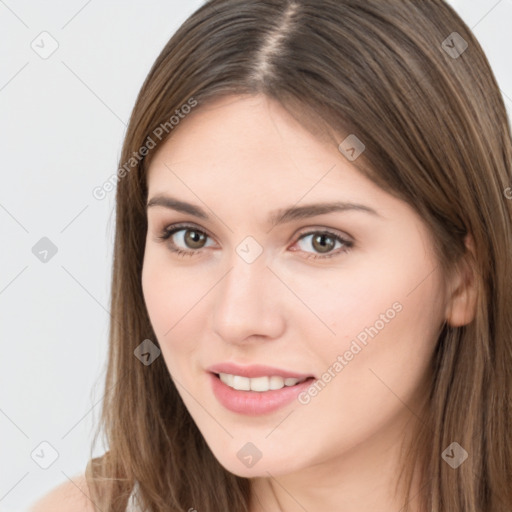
[{"x1": 144, "y1": 95, "x2": 383, "y2": 201}]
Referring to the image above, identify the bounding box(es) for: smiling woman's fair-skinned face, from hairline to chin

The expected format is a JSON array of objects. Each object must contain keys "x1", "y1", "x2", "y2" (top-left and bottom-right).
[{"x1": 142, "y1": 96, "x2": 447, "y2": 477}]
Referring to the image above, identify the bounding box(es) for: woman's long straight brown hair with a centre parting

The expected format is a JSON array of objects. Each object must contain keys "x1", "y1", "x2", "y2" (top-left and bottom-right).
[{"x1": 87, "y1": 0, "x2": 512, "y2": 512}]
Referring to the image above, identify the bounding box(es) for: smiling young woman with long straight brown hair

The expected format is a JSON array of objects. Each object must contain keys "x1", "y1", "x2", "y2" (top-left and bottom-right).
[{"x1": 33, "y1": 0, "x2": 512, "y2": 512}]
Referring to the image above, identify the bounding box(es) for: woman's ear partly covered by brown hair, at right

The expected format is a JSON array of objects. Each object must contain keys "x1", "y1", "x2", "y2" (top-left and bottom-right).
[{"x1": 446, "y1": 234, "x2": 477, "y2": 327}]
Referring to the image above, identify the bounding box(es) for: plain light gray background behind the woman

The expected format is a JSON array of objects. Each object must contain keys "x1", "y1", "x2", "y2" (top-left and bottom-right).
[{"x1": 0, "y1": 0, "x2": 512, "y2": 512}]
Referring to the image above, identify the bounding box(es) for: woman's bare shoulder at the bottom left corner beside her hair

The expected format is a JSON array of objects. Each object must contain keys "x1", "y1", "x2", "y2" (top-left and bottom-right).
[{"x1": 29, "y1": 475, "x2": 95, "y2": 512}]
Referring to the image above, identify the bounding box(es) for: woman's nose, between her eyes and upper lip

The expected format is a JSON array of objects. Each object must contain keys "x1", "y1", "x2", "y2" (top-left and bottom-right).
[{"x1": 213, "y1": 254, "x2": 285, "y2": 343}]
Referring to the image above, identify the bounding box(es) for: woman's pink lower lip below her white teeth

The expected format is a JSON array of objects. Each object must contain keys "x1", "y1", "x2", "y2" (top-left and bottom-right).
[{"x1": 210, "y1": 373, "x2": 314, "y2": 416}]
